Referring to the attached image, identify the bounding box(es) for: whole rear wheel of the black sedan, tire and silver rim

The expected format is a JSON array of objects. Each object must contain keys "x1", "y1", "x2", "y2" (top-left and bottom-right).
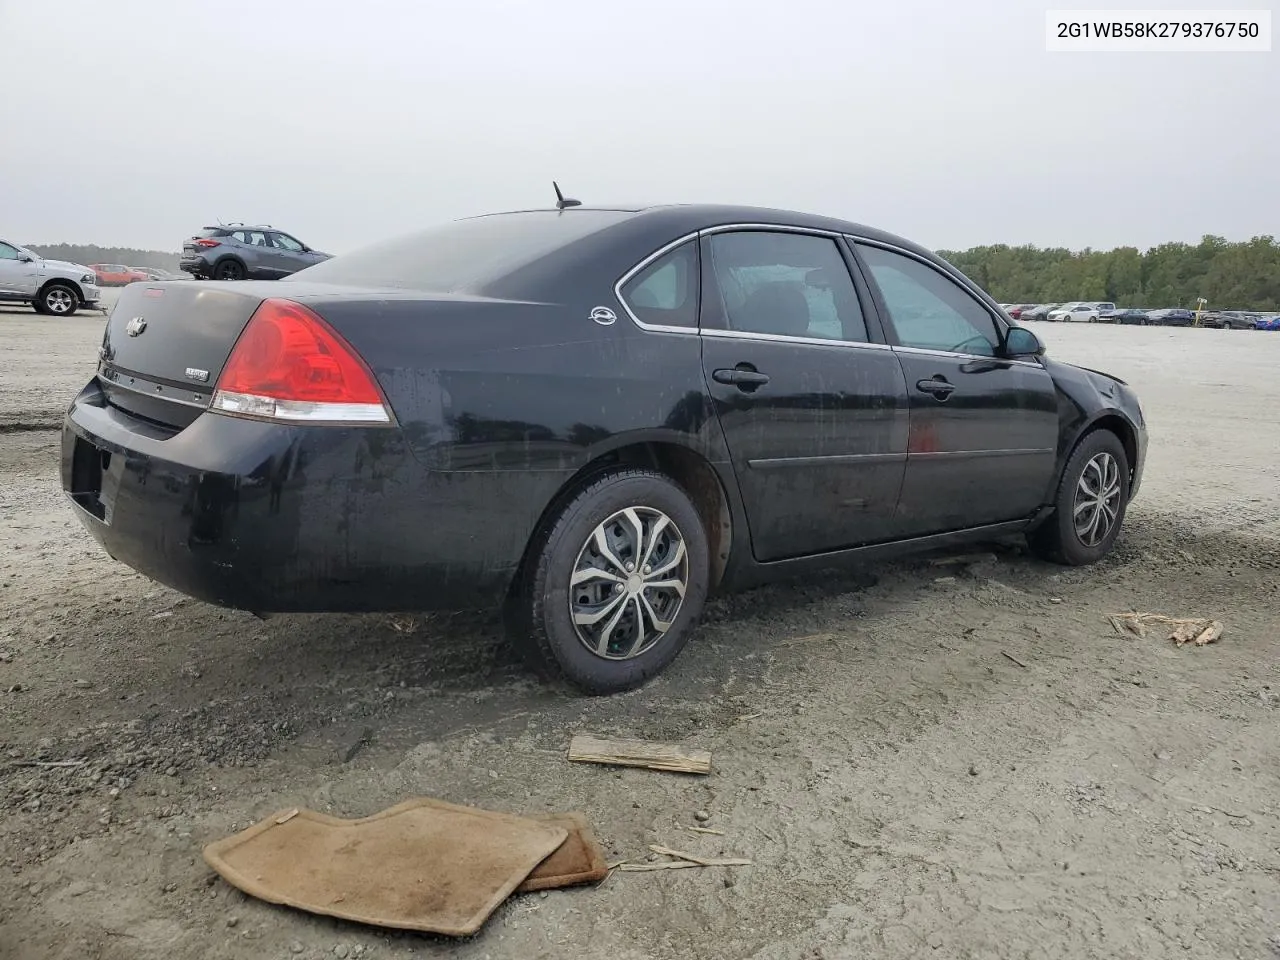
[{"x1": 507, "y1": 467, "x2": 709, "y2": 694}]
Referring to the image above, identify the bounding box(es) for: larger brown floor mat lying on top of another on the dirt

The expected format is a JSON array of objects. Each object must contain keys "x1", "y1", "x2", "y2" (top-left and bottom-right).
[{"x1": 204, "y1": 797, "x2": 568, "y2": 937}]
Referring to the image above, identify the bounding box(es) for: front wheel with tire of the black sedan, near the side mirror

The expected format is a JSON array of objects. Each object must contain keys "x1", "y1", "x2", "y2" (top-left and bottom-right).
[{"x1": 1028, "y1": 430, "x2": 1129, "y2": 567}]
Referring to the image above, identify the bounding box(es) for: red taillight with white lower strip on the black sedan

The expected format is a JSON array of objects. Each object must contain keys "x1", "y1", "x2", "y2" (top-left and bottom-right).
[{"x1": 211, "y1": 298, "x2": 390, "y2": 424}]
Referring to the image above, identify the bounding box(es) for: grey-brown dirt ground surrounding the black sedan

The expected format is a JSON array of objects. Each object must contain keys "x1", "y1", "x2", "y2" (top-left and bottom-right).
[{"x1": 0, "y1": 310, "x2": 1280, "y2": 960}]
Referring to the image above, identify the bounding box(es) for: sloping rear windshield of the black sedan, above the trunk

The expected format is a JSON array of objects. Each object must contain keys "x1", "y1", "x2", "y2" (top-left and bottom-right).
[{"x1": 285, "y1": 210, "x2": 631, "y2": 293}]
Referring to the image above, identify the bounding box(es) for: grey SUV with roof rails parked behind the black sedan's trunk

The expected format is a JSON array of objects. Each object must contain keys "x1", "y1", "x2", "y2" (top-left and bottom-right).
[{"x1": 179, "y1": 224, "x2": 329, "y2": 280}]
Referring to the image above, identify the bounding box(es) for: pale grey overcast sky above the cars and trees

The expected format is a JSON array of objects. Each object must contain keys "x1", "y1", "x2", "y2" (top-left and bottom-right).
[{"x1": 0, "y1": 0, "x2": 1280, "y2": 252}]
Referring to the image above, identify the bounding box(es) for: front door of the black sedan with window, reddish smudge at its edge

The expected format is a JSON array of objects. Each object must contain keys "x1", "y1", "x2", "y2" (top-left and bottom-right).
[{"x1": 855, "y1": 242, "x2": 1059, "y2": 536}]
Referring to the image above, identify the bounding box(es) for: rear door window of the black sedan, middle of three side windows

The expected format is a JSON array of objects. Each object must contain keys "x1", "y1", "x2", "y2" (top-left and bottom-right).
[{"x1": 710, "y1": 230, "x2": 867, "y2": 343}]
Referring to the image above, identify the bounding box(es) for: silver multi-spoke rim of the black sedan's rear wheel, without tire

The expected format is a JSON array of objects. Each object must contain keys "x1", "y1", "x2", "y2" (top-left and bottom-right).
[{"x1": 568, "y1": 507, "x2": 689, "y2": 660}]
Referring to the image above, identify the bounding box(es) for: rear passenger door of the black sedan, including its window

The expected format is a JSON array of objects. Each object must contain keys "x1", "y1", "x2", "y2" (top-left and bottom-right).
[{"x1": 700, "y1": 229, "x2": 909, "y2": 561}]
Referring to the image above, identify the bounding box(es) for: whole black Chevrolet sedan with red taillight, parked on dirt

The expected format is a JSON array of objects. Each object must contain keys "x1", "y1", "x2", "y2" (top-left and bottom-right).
[{"x1": 61, "y1": 205, "x2": 1147, "y2": 692}]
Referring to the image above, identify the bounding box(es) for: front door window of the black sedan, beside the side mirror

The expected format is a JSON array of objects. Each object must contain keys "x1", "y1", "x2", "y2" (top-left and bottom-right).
[{"x1": 858, "y1": 243, "x2": 1000, "y2": 357}]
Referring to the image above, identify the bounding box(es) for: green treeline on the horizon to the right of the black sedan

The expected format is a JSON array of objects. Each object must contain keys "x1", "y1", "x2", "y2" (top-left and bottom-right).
[{"x1": 938, "y1": 237, "x2": 1280, "y2": 310}]
